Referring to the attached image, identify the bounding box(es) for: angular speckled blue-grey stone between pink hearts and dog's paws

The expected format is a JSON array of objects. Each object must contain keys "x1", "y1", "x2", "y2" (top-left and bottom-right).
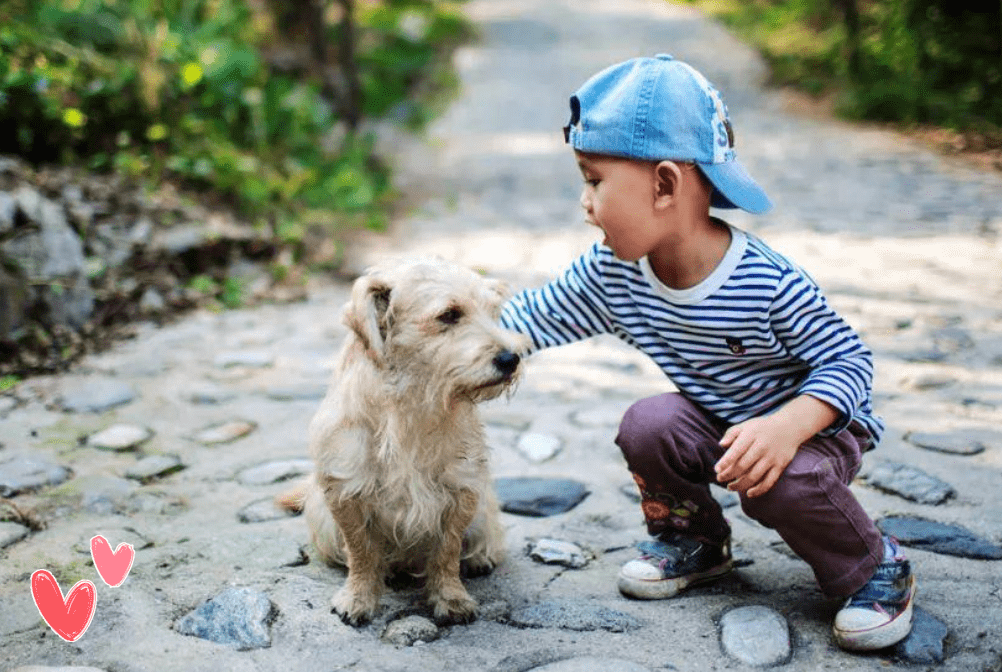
[{"x1": 174, "y1": 588, "x2": 278, "y2": 651}]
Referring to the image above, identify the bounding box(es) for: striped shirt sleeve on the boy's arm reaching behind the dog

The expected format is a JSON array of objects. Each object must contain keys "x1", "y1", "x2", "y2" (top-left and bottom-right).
[{"x1": 501, "y1": 245, "x2": 612, "y2": 352}]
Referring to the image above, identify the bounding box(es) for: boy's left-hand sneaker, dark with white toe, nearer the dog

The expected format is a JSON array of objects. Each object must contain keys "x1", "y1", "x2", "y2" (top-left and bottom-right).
[{"x1": 619, "y1": 534, "x2": 734, "y2": 600}]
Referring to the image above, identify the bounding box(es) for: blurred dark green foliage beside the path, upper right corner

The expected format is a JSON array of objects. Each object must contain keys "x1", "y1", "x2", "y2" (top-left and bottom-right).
[{"x1": 688, "y1": 0, "x2": 1002, "y2": 131}]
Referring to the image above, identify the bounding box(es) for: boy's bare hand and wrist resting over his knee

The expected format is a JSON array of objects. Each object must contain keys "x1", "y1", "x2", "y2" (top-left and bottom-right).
[{"x1": 715, "y1": 395, "x2": 840, "y2": 497}]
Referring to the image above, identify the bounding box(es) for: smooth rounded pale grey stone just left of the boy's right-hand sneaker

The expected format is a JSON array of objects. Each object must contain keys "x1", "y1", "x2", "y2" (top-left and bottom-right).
[{"x1": 720, "y1": 606, "x2": 791, "y2": 667}]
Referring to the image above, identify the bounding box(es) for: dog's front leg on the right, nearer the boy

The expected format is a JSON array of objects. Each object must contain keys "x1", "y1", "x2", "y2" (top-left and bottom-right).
[{"x1": 428, "y1": 490, "x2": 477, "y2": 623}]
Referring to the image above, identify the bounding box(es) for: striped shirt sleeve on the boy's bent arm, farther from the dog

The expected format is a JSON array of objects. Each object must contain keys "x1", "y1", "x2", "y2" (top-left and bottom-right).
[{"x1": 772, "y1": 270, "x2": 874, "y2": 436}]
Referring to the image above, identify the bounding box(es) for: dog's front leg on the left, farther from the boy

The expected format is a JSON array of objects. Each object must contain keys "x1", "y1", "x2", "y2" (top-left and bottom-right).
[{"x1": 327, "y1": 491, "x2": 385, "y2": 625}]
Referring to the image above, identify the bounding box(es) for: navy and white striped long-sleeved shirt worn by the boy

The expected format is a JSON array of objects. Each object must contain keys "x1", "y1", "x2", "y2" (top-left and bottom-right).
[{"x1": 501, "y1": 227, "x2": 884, "y2": 443}]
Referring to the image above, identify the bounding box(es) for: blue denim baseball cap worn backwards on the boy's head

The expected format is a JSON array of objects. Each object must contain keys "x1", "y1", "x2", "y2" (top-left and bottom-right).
[{"x1": 564, "y1": 54, "x2": 773, "y2": 214}]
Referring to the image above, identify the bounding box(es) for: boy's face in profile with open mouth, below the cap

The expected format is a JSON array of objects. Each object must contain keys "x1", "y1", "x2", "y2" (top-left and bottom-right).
[{"x1": 574, "y1": 151, "x2": 660, "y2": 261}]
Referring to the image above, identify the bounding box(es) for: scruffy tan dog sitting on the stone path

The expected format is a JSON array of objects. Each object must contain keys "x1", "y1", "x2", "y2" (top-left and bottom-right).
[{"x1": 281, "y1": 259, "x2": 526, "y2": 625}]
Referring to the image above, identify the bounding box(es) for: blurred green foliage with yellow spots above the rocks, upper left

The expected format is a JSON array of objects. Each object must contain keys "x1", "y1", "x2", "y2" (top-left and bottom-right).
[{"x1": 0, "y1": 0, "x2": 465, "y2": 228}]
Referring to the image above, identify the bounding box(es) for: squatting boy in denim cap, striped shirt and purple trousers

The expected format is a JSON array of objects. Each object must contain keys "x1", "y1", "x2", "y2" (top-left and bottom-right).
[{"x1": 501, "y1": 54, "x2": 915, "y2": 650}]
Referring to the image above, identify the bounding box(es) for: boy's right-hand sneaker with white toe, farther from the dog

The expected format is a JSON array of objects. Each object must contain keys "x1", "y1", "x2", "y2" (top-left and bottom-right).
[{"x1": 832, "y1": 558, "x2": 916, "y2": 651}]
